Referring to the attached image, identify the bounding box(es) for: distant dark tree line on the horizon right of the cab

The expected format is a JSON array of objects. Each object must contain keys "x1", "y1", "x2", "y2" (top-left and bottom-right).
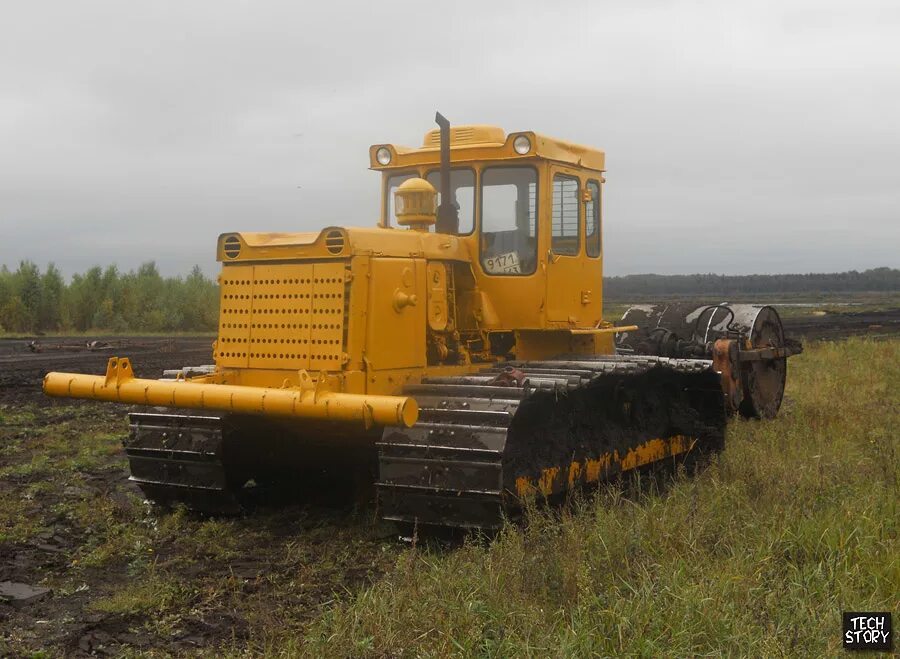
[{"x1": 603, "y1": 268, "x2": 900, "y2": 300}]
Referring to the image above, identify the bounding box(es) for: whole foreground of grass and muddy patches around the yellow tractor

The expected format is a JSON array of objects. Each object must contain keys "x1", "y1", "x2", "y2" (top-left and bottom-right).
[{"x1": 0, "y1": 339, "x2": 900, "y2": 657}]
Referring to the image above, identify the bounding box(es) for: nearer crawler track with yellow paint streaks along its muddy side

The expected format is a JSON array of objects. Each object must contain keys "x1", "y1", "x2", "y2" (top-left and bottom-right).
[{"x1": 377, "y1": 356, "x2": 725, "y2": 529}]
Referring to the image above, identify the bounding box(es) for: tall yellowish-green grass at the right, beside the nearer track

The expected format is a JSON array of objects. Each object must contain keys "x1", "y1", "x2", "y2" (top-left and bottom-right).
[{"x1": 296, "y1": 340, "x2": 900, "y2": 657}]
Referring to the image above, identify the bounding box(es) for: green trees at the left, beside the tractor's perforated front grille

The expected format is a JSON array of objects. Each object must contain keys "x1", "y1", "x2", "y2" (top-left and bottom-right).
[{"x1": 0, "y1": 261, "x2": 219, "y2": 333}]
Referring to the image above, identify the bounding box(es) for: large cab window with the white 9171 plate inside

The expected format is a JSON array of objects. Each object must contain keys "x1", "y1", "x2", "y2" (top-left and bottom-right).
[{"x1": 481, "y1": 167, "x2": 537, "y2": 275}]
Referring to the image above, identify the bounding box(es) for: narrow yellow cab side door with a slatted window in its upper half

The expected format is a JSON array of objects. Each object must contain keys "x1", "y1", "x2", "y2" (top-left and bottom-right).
[{"x1": 545, "y1": 167, "x2": 590, "y2": 325}]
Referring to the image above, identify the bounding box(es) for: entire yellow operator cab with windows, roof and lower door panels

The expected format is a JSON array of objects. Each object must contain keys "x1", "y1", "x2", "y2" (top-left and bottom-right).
[{"x1": 369, "y1": 115, "x2": 605, "y2": 328}]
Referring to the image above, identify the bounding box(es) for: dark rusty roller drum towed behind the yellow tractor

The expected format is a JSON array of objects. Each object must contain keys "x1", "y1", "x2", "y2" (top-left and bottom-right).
[{"x1": 617, "y1": 302, "x2": 787, "y2": 419}]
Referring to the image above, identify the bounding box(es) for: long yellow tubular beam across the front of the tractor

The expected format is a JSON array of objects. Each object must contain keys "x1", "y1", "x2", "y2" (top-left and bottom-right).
[{"x1": 44, "y1": 357, "x2": 419, "y2": 428}]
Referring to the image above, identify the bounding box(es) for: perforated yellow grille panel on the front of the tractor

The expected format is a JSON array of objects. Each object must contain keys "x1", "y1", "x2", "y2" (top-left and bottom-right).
[{"x1": 216, "y1": 262, "x2": 345, "y2": 371}]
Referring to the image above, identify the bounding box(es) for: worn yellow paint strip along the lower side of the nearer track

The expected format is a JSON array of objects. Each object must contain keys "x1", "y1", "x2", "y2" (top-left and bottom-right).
[{"x1": 515, "y1": 435, "x2": 696, "y2": 497}]
